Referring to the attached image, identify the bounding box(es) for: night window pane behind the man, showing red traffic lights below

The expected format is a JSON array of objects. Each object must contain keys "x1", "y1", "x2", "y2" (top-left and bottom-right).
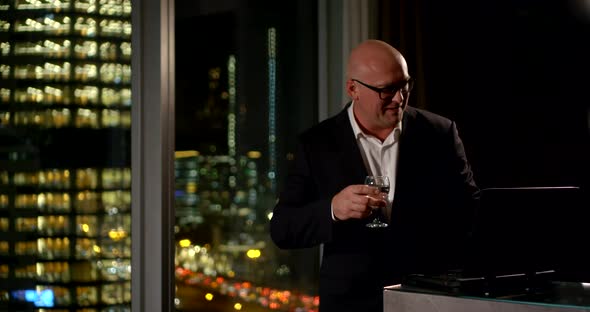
[{"x1": 175, "y1": 1, "x2": 319, "y2": 311}]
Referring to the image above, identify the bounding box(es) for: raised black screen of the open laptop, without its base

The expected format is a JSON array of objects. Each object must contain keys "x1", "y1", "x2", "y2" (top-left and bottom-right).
[{"x1": 467, "y1": 186, "x2": 590, "y2": 279}]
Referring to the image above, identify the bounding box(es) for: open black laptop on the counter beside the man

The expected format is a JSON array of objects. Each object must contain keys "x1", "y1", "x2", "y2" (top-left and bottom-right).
[{"x1": 406, "y1": 186, "x2": 590, "y2": 293}]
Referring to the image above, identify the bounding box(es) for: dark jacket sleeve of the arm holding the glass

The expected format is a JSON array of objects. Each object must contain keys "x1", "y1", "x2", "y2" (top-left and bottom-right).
[{"x1": 270, "y1": 141, "x2": 333, "y2": 249}]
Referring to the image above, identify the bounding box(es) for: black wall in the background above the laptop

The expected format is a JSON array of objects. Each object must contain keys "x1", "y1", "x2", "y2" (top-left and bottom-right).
[{"x1": 381, "y1": 0, "x2": 590, "y2": 187}]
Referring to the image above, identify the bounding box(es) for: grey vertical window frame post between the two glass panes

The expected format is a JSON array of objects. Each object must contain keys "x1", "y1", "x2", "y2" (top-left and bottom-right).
[{"x1": 131, "y1": 0, "x2": 175, "y2": 312}]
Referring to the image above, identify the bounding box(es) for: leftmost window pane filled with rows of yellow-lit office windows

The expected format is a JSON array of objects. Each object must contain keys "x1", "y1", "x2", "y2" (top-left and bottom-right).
[{"x1": 0, "y1": 0, "x2": 131, "y2": 311}]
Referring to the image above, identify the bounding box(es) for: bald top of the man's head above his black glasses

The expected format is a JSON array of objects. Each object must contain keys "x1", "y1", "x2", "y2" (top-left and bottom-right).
[{"x1": 347, "y1": 39, "x2": 408, "y2": 84}]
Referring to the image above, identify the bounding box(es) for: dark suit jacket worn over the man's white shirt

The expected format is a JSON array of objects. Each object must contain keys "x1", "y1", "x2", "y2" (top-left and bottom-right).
[{"x1": 270, "y1": 104, "x2": 478, "y2": 312}]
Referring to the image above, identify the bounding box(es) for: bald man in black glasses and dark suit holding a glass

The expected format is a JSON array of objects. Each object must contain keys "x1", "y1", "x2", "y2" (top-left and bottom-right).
[{"x1": 270, "y1": 40, "x2": 479, "y2": 312}]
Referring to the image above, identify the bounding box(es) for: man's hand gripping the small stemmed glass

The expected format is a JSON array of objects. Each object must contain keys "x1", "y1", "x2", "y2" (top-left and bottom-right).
[{"x1": 332, "y1": 184, "x2": 386, "y2": 220}]
